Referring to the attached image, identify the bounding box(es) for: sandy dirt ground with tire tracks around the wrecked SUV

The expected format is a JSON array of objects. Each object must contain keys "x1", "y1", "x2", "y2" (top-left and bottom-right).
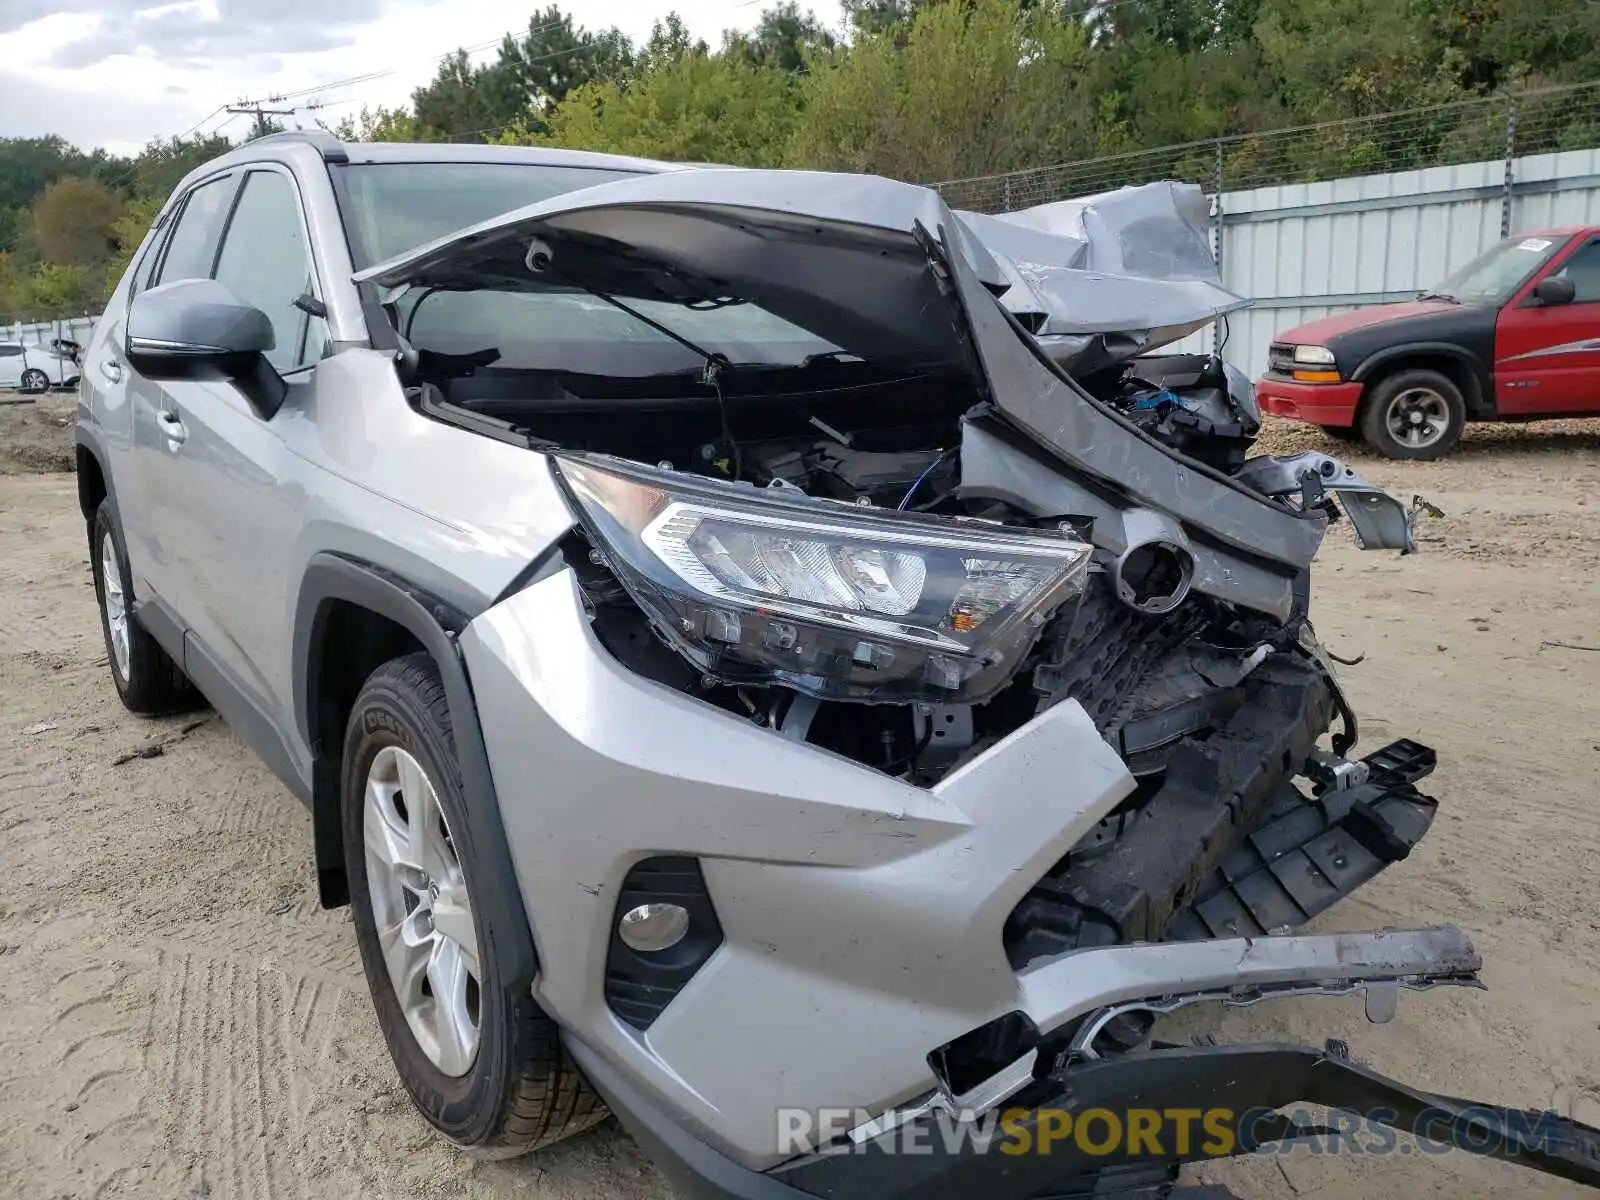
[{"x1": 0, "y1": 400, "x2": 1600, "y2": 1200}]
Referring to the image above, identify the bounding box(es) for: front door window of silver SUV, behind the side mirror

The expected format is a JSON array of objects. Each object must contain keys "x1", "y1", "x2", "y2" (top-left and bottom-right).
[{"x1": 216, "y1": 171, "x2": 328, "y2": 371}]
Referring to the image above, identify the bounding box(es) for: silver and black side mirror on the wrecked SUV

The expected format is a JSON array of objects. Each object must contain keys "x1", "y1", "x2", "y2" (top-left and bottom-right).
[{"x1": 123, "y1": 278, "x2": 288, "y2": 419}]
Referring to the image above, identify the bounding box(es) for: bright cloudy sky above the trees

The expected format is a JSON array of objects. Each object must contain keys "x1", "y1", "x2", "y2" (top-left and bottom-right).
[{"x1": 0, "y1": 0, "x2": 800, "y2": 154}]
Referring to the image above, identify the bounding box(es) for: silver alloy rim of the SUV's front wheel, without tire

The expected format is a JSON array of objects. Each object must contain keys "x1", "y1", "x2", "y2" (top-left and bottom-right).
[{"x1": 362, "y1": 746, "x2": 482, "y2": 1077}]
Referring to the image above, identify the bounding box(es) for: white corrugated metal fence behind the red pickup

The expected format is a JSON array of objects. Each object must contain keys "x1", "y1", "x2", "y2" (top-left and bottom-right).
[{"x1": 1182, "y1": 150, "x2": 1600, "y2": 378}]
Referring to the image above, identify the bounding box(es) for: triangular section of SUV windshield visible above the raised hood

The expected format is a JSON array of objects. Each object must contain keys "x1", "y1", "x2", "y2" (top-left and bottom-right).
[{"x1": 342, "y1": 163, "x2": 632, "y2": 270}]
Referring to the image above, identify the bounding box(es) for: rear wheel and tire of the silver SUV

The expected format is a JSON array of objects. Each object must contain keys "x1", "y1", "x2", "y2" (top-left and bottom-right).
[{"x1": 90, "y1": 496, "x2": 205, "y2": 717}]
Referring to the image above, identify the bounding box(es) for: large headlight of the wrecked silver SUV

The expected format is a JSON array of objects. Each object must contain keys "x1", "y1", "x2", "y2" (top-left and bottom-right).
[{"x1": 557, "y1": 456, "x2": 1091, "y2": 702}]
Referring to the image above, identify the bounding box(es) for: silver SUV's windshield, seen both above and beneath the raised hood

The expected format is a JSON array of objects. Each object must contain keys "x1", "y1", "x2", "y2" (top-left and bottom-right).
[{"x1": 344, "y1": 163, "x2": 838, "y2": 376}]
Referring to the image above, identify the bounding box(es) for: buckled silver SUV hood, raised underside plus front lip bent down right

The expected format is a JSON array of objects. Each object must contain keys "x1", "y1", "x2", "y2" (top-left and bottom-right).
[{"x1": 357, "y1": 168, "x2": 1323, "y2": 587}]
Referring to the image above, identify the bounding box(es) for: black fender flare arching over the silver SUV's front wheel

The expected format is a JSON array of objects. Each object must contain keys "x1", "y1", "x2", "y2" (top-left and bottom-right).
[{"x1": 293, "y1": 552, "x2": 538, "y2": 990}]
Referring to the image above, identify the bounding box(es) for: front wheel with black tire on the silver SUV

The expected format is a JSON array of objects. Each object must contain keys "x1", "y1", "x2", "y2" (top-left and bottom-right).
[{"x1": 341, "y1": 653, "x2": 606, "y2": 1158}]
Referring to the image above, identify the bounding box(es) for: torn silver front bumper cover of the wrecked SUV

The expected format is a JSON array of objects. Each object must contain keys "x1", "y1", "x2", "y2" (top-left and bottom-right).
[{"x1": 461, "y1": 570, "x2": 1478, "y2": 1171}]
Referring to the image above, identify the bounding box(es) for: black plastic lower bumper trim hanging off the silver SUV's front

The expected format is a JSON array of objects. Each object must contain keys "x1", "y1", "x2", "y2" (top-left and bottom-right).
[{"x1": 568, "y1": 1038, "x2": 1600, "y2": 1200}]
